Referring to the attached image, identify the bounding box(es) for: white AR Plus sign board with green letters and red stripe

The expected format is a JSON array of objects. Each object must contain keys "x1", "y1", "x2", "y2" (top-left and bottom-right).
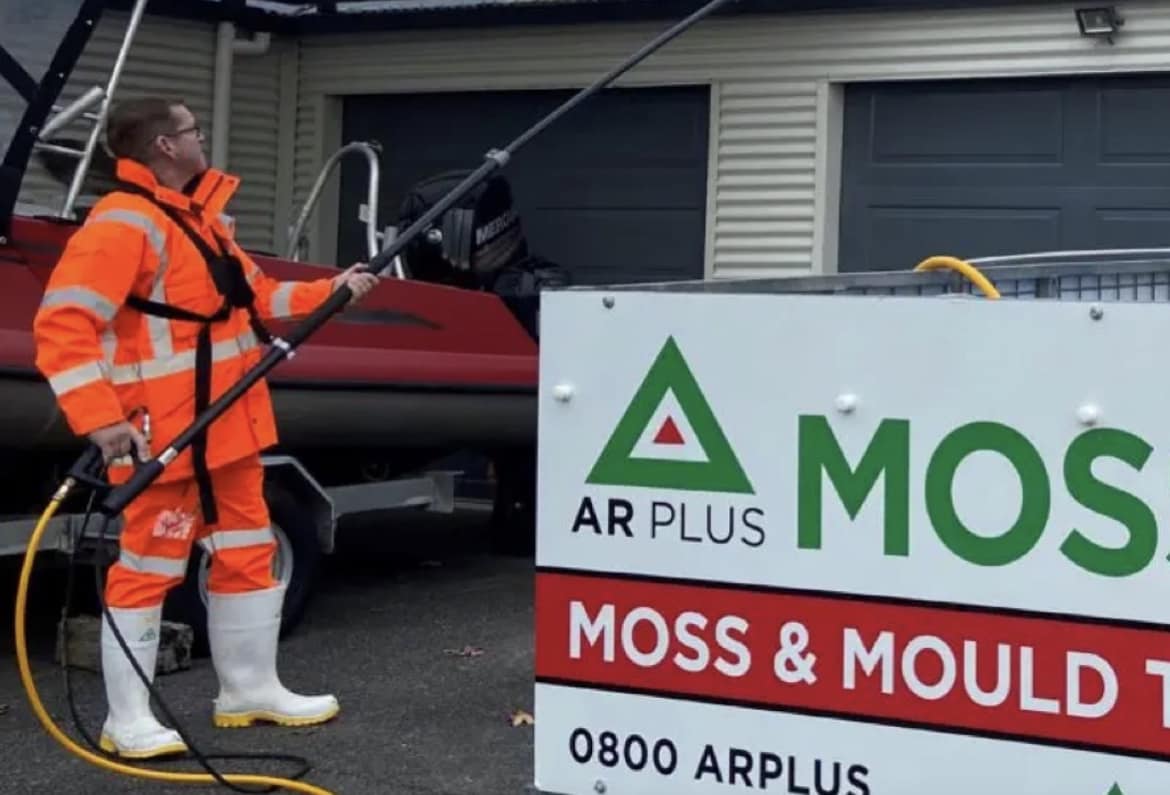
[{"x1": 535, "y1": 292, "x2": 1170, "y2": 795}]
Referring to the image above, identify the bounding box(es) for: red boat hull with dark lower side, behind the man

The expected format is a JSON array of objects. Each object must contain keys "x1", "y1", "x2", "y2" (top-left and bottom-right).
[{"x1": 0, "y1": 218, "x2": 538, "y2": 462}]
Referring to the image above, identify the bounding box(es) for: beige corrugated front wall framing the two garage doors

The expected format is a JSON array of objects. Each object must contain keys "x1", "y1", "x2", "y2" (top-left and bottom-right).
[{"x1": 291, "y1": 0, "x2": 1170, "y2": 277}]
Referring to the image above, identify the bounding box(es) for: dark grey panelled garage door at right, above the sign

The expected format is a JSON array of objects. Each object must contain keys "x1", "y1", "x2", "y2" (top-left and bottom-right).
[{"x1": 840, "y1": 76, "x2": 1170, "y2": 270}]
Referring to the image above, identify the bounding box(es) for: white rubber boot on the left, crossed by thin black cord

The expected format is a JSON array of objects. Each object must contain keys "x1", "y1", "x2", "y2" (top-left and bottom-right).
[{"x1": 98, "y1": 605, "x2": 187, "y2": 759}]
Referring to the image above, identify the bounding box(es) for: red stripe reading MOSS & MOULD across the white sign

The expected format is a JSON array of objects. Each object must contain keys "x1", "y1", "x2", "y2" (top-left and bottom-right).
[{"x1": 536, "y1": 573, "x2": 1170, "y2": 759}]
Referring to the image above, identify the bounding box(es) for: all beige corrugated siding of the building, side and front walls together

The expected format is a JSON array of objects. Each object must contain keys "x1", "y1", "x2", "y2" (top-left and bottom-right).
[{"x1": 21, "y1": 0, "x2": 1170, "y2": 277}]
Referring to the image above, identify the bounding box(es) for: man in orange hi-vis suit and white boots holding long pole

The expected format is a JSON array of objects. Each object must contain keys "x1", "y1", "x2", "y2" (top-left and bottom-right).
[{"x1": 34, "y1": 98, "x2": 378, "y2": 759}]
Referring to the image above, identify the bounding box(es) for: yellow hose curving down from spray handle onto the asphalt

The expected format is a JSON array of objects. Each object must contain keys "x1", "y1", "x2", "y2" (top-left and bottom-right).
[{"x1": 16, "y1": 478, "x2": 333, "y2": 795}]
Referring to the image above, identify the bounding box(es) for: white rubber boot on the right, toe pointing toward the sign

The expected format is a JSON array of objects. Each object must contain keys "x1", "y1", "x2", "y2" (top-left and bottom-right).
[{"x1": 207, "y1": 585, "x2": 340, "y2": 728}]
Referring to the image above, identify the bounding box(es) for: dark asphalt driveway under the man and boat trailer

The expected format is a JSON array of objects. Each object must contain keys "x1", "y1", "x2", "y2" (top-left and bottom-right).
[{"x1": 0, "y1": 510, "x2": 532, "y2": 795}]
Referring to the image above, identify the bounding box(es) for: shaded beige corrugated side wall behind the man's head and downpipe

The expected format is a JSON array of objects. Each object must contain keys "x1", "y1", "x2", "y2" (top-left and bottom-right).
[{"x1": 13, "y1": 12, "x2": 280, "y2": 248}]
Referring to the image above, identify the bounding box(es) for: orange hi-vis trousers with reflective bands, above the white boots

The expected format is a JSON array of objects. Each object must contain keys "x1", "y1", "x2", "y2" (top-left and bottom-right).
[{"x1": 105, "y1": 455, "x2": 276, "y2": 608}]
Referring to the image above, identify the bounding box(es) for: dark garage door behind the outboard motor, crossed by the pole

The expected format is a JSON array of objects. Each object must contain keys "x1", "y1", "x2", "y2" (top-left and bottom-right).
[{"x1": 338, "y1": 87, "x2": 708, "y2": 283}]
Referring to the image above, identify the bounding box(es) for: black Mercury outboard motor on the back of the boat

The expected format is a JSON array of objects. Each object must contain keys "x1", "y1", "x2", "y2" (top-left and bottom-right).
[{"x1": 398, "y1": 171, "x2": 569, "y2": 340}]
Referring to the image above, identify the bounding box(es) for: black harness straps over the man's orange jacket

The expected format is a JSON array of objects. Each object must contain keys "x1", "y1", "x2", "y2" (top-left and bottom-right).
[{"x1": 124, "y1": 184, "x2": 273, "y2": 525}]
